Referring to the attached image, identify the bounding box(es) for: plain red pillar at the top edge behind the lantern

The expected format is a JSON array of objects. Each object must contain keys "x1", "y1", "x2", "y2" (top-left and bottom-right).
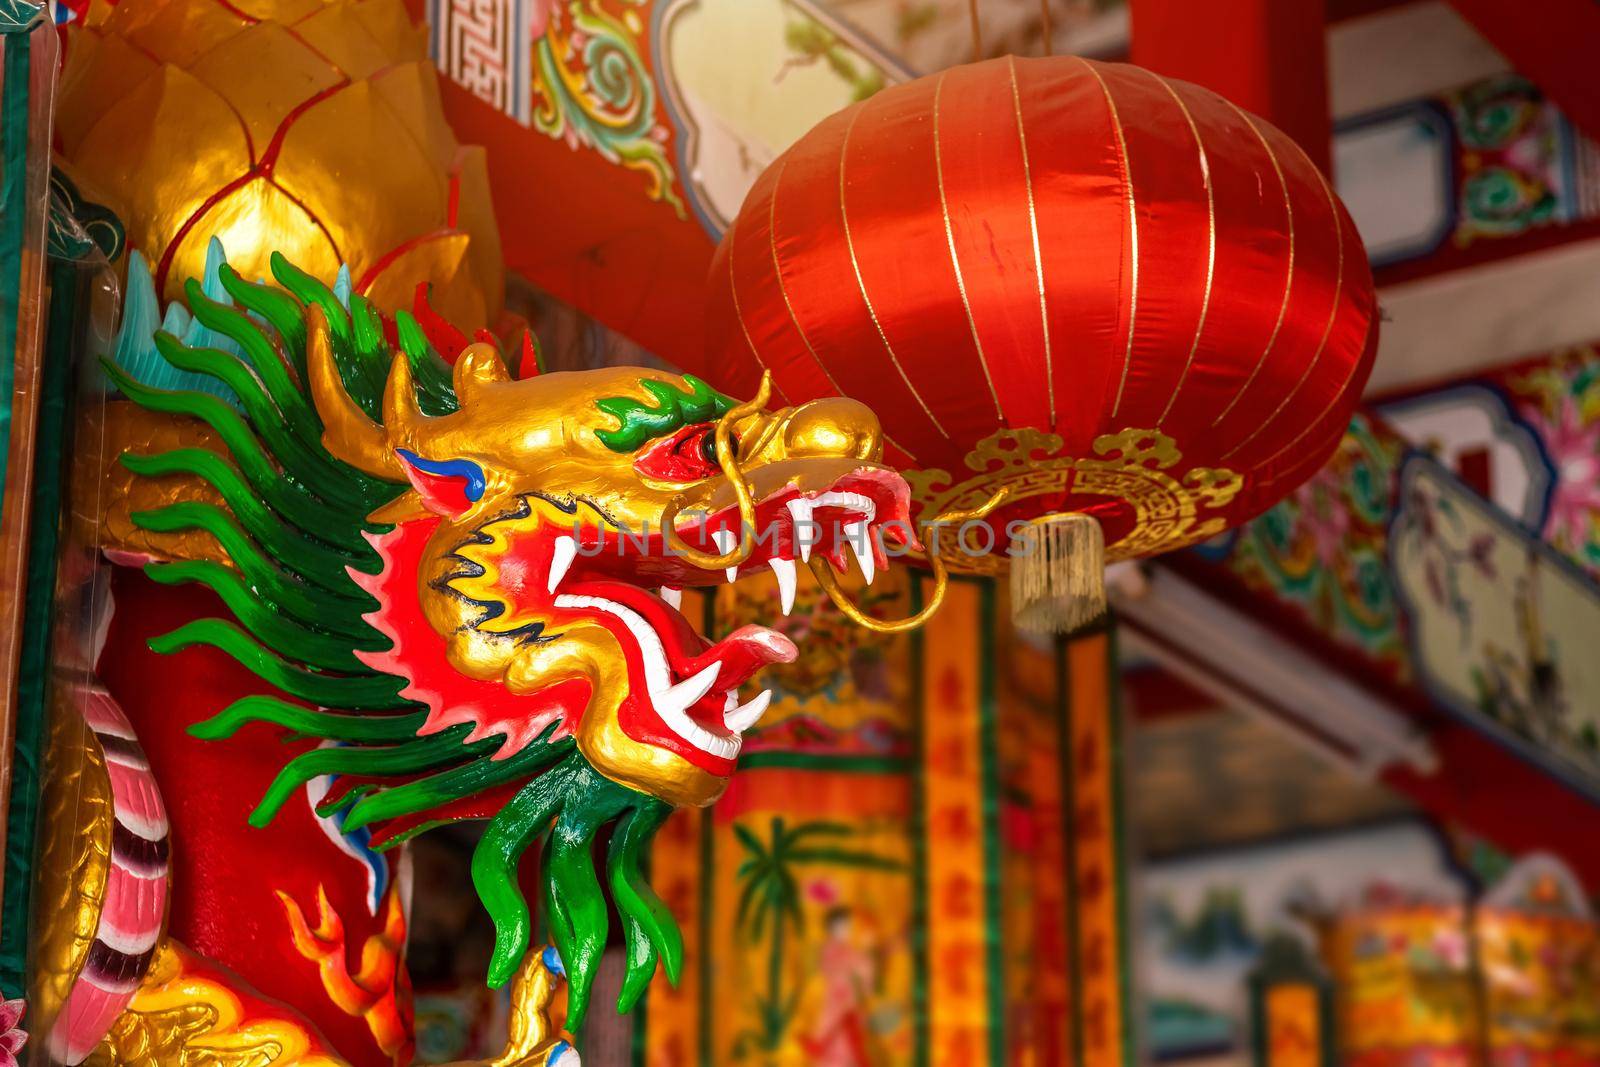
[{"x1": 1130, "y1": 0, "x2": 1331, "y2": 171}]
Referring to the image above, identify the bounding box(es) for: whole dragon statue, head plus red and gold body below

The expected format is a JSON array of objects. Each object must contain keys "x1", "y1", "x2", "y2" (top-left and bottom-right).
[{"x1": 34, "y1": 254, "x2": 972, "y2": 1067}]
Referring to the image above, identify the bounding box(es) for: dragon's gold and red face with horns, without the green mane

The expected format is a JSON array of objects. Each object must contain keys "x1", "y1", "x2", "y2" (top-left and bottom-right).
[{"x1": 312, "y1": 327, "x2": 914, "y2": 806}]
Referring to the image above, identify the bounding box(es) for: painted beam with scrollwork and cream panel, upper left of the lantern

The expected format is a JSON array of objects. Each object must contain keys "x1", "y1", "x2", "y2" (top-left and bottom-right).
[{"x1": 427, "y1": 0, "x2": 909, "y2": 237}]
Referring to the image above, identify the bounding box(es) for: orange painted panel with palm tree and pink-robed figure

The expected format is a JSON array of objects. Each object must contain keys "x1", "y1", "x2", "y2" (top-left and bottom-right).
[{"x1": 707, "y1": 768, "x2": 914, "y2": 1067}]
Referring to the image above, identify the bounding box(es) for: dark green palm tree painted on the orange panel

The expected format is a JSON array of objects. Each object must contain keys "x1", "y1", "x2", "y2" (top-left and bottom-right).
[{"x1": 733, "y1": 816, "x2": 906, "y2": 1057}]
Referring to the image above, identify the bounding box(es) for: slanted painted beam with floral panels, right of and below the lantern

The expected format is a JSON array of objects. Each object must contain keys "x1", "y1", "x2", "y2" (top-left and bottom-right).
[{"x1": 1195, "y1": 371, "x2": 1600, "y2": 790}]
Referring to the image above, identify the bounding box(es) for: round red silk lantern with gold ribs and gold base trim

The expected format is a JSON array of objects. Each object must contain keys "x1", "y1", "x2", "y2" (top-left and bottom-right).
[{"x1": 699, "y1": 58, "x2": 1378, "y2": 627}]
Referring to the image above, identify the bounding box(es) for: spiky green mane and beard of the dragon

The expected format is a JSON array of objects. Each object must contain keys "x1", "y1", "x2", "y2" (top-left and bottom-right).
[{"x1": 106, "y1": 242, "x2": 683, "y2": 1030}]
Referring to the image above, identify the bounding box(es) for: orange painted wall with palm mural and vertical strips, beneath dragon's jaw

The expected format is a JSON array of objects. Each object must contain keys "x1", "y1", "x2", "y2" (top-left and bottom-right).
[{"x1": 635, "y1": 571, "x2": 1133, "y2": 1067}]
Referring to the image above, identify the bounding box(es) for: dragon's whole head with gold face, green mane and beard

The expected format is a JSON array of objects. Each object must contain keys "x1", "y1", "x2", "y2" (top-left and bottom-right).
[{"x1": 116, "y1": 256, "x2": 944, "y2": 1027}]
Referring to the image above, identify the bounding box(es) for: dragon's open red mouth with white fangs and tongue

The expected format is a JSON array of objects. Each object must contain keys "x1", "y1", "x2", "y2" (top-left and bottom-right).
[{"x1": 473, "y1": 467, "x2": 915, "y2": 776}]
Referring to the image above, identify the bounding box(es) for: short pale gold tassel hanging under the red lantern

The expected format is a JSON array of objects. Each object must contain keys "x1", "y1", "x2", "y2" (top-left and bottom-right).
[{"x1": 1011, "y1": 514, "x2": 1106, "y2": 633}]
